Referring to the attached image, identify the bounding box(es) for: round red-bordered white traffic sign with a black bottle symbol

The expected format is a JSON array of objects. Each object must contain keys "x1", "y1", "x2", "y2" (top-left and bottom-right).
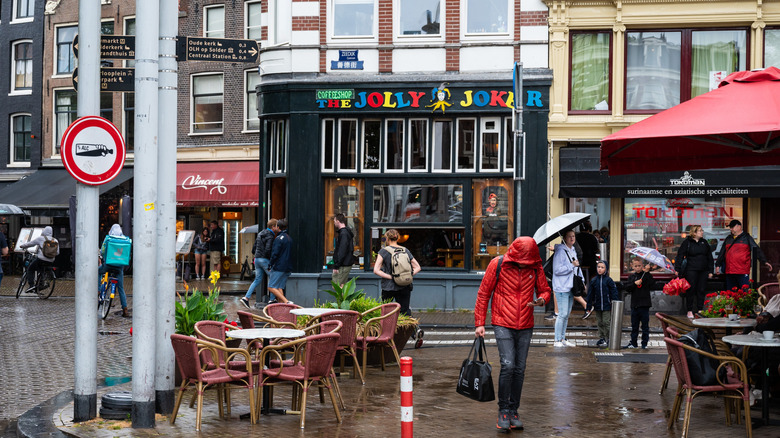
[{"x1": 61, "y1": 116, "x2": 125, "y2": 185}]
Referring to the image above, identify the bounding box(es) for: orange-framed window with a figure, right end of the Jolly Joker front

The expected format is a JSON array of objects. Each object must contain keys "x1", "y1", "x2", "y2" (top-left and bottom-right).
[{"x1": 471, "y1": 179, "x2": 514, "y2": 270}]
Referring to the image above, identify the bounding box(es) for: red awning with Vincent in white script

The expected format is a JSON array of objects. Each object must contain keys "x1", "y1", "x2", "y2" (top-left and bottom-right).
[{"x1": 176, "y1": 161, "x2": 260, "y2": 207}]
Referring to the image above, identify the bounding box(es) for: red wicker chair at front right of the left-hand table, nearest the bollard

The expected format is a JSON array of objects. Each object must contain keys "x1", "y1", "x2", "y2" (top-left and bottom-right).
[{"x1": 260, "y1": 333, "x2": 341, "y2": 429}]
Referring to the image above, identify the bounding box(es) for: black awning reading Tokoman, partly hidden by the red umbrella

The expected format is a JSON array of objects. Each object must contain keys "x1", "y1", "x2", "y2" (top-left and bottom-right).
[{"x1": 558, "y1": 147, "x2": 780, "y2": 198}]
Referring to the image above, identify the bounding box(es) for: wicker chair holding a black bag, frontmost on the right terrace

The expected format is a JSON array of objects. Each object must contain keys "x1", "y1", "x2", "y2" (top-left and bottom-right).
[{"x1": 664, "y1": 330, "x2": 753, "y2": 438}]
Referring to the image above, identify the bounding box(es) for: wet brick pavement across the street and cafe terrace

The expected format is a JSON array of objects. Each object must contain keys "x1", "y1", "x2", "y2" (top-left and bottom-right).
[{"x1": 0, "y1": 277, "x2": 780, "y2": 438}]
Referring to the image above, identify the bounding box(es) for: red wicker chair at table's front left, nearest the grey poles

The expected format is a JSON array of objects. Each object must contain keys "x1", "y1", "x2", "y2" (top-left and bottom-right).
[{"x1": 171, "y1": 334, "x2": 257, "y2": 431}]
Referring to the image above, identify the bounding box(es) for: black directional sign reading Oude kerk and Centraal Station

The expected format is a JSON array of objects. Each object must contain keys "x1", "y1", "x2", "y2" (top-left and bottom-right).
[{"x1": 176, "y1": 36, "x2": 260, "y2": 63}]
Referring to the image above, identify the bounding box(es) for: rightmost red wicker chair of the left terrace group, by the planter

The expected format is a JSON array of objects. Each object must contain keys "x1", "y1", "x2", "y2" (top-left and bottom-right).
[{"x1": 355, "y1": 303, "x2": 401, "y2": 377}]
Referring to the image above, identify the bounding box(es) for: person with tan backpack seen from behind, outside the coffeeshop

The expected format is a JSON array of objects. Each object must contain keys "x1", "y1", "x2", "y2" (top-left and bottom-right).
[{"x1": 374, "y1": 229, "x2": 422, "y2": 316}]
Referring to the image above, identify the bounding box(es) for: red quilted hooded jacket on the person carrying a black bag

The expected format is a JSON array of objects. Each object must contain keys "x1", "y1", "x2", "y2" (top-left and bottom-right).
[{"x1": 474, "y1": 237, "x2": 550, "y2": 330}]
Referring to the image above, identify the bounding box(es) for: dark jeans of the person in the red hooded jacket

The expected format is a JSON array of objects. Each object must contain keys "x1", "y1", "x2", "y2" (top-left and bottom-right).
[{"x1": 493, "y1": 326, "x2": 532, "y2": 412}]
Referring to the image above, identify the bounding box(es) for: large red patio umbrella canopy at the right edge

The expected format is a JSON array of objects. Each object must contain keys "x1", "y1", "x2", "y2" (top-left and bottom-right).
[{"x1": 601, "y1": 67, "x2": 780, "y2": 175}]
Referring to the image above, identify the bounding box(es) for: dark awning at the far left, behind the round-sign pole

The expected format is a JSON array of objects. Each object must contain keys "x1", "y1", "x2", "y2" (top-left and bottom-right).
[{"x1": 0, "y1": 168, "x2": 133, "y2": 209}]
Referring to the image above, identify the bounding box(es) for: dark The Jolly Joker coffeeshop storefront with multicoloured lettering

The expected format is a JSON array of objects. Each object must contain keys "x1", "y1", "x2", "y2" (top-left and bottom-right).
[{"x1": 258, "y1": 71, "x2": 550, "y2": 309}]
